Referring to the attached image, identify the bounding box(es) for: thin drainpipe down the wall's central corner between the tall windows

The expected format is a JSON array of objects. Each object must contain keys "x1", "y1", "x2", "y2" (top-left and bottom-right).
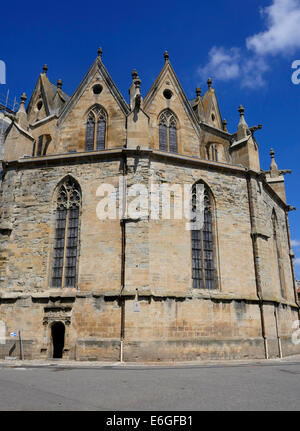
[{"x1": 119, "y1": 153, "x2": 127, "y2": 362}]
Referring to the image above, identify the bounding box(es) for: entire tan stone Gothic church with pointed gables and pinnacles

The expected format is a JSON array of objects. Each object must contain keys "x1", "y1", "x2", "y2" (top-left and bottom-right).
[{"x1": 0, "y1": 48, "x2": 300, "y2": 361}]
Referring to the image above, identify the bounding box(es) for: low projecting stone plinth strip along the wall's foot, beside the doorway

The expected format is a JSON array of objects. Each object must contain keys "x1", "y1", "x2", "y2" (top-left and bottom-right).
[{"x1": 0, "y1": 337, "x2": 300, "y2": 362}]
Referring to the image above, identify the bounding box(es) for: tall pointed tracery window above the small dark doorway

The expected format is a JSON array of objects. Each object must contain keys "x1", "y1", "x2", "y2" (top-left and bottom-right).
[{"x1": 52, "y1": 177, "x2": 81, "y2": 287}]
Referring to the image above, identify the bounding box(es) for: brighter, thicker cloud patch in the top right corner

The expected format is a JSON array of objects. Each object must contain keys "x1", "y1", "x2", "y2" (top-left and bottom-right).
[{"x1": 246, "y1": 0, "x2": 300, "y2": 55}]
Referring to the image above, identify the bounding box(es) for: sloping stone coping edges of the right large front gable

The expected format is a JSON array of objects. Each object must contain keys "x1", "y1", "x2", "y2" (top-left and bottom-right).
[{"x1": 143, "y1": 60, "x2": 200, "y2": 136}]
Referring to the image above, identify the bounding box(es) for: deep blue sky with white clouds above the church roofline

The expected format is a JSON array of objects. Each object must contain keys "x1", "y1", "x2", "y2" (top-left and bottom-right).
[{"x1": 0, "y1": 0, "x2": 300, "y2": 279}]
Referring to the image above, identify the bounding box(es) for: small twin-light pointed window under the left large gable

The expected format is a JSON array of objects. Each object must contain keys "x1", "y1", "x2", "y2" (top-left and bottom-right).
[{"x1": 85, "y1": 105, "x2": 107, "y2": 151}]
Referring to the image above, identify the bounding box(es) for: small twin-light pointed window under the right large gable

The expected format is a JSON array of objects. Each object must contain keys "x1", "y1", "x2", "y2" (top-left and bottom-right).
[{"x1": 158, "y1": 109, "x2": 178, "y2": 153}]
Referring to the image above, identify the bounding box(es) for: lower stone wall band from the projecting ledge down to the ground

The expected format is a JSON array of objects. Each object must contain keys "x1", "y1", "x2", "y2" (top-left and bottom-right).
[{"x1": 0, "y1": 295, "x2": 300, "y2": 362}]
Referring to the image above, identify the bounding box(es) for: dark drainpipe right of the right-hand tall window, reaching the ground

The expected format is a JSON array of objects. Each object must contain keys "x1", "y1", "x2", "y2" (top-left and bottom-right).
[{"x1": 246, "y1": 174, "x2": 269, "y2": 359}]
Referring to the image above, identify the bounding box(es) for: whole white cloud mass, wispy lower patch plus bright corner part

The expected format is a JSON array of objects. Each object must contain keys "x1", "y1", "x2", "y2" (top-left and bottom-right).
[{"x1": 198, "y1": 0, "x2": 300, "y2": 88}]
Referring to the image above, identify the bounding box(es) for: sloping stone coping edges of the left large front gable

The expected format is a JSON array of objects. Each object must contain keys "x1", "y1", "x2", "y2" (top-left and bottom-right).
[{"x1": 58, "y1": 57, "x2": 130, "y2": 125}]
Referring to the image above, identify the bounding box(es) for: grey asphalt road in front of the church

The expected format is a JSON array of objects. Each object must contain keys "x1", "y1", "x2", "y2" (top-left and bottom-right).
[{"x1": 0, "y1": 362, "x2": 300, "y2": 411}]
